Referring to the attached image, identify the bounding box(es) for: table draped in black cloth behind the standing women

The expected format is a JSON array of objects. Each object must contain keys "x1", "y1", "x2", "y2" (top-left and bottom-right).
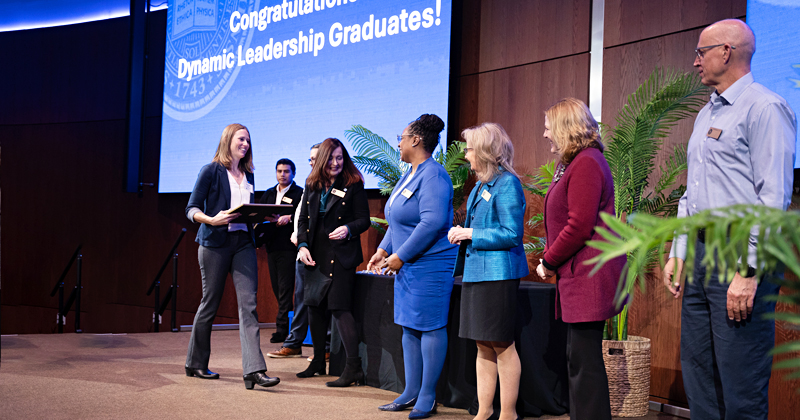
[{"x1": 330, "y1": 273, "x2": 569, "y2": 417}]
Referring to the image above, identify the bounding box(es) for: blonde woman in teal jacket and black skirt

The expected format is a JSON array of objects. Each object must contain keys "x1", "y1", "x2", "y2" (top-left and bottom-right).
[{"x1": 448, "y1": 123, "x2": 528, "y2": 420}]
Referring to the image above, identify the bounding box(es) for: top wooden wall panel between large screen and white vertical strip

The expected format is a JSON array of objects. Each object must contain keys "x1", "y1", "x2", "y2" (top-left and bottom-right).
[{"x1": 476, "y1": 0, "x2": 591, "y2": 72}]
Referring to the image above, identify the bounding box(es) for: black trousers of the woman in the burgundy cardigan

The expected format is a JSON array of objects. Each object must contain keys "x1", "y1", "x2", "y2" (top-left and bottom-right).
[{"x1": 567, "y1": 321, "x2": 611, "y2": 420}]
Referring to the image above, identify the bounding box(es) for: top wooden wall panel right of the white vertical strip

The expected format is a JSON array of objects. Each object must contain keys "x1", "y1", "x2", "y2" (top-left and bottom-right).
[{"x1": 603, "y1": 0, "x2": 747, "y2": 48}]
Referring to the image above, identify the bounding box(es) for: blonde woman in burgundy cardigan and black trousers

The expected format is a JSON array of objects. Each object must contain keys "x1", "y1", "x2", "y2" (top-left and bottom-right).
[{"x1": 536, "y1": 98, "x2": 625, "y2": 420}]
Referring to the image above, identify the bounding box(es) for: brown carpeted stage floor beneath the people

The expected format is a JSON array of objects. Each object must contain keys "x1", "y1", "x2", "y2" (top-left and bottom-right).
[{"x1": 0, "y1": 329, "x2": 677, "y2": 420}]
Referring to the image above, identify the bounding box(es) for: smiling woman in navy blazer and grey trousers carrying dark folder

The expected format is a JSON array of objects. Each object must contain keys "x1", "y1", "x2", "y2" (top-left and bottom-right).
[{"x1": 186, "y1": 124, "x2": 280, "y2": 389}]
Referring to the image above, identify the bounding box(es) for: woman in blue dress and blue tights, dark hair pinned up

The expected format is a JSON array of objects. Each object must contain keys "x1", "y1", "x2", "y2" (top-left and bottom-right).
[{"x1": 367, "y1": 114, "x2": 458, "y2": 419}]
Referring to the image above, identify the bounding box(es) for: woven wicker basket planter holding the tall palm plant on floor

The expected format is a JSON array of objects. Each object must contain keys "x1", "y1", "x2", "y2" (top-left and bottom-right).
[{"x1": 603, "y1": 336, "x2": 650, "y2": 417}]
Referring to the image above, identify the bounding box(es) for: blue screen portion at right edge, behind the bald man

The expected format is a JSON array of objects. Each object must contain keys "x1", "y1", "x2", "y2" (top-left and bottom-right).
[{"x1": 747, "y1": 0, "x2": 800, "y2": 168}]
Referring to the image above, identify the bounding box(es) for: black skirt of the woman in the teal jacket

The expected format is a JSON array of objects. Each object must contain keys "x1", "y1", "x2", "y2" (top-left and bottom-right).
[{"x1": 458, "y1": 279, "x2": 519, "y2": 342}]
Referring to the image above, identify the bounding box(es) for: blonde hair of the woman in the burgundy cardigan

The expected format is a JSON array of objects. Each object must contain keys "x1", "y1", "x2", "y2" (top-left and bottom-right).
[{"x1": 544, "y1": 98, "x2": 603, "y2": 165}]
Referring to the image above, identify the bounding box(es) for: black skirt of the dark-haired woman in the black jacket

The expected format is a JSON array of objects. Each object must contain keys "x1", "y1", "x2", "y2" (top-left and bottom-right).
[{"x1": 303, "y1": 217, "x2": 356, "y2": 311}]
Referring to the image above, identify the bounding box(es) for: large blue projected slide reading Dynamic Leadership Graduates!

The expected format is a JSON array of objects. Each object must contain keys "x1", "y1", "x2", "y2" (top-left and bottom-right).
[{"x1": 158, "y1": 0, "x2": 451, "y2": 192}]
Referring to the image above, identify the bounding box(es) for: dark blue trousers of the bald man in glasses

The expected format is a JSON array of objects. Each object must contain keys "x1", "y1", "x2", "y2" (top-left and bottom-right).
[{"x1": 681, "y1": 242, "x2": 780, "y2": 420}]
